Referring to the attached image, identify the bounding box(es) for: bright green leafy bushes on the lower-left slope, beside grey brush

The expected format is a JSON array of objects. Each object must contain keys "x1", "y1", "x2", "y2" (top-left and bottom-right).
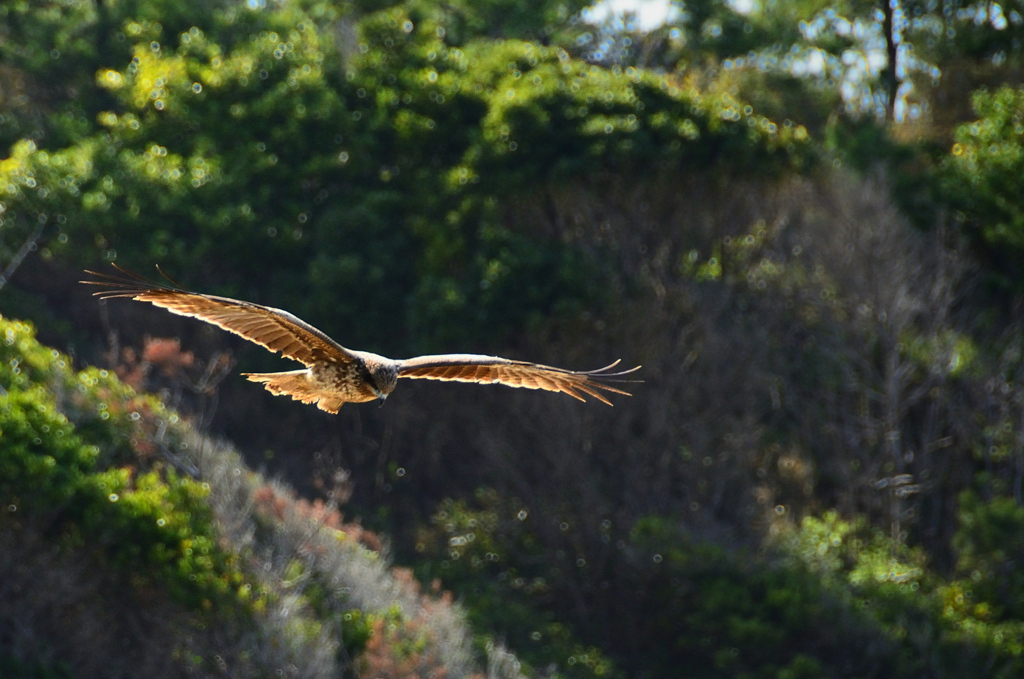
[{"x1": 0, "y1": 319, "x2": 256, "y2": 614}]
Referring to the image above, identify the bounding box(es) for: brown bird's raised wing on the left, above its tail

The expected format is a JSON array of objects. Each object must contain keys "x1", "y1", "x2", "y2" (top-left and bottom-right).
[{"x1": 82, "y1": 264, "x2": 355, "y2": 366}]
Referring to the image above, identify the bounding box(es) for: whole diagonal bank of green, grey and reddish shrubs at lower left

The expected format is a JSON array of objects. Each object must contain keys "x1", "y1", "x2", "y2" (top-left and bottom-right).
[{"x1": 0, "y1": 316, "x2": 468, "y2": 677}]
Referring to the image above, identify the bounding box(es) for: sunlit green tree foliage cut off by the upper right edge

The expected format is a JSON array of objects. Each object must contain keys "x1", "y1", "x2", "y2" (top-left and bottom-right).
[{"x1": 942, "y1": 87, "x2": 1024, "y2": 290}]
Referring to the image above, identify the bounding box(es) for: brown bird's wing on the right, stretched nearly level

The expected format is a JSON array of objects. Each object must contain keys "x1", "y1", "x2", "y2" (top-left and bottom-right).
[{"x1": 398, "y1": 353, "x2": 640, "y2": 406}]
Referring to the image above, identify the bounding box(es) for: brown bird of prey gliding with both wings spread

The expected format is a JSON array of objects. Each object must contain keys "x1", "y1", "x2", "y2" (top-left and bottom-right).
[{"x1": 82, "y1": 264, "x2": 640, "y2": 413}]
